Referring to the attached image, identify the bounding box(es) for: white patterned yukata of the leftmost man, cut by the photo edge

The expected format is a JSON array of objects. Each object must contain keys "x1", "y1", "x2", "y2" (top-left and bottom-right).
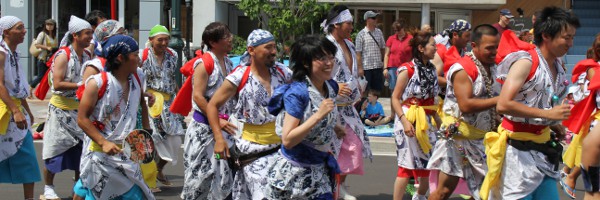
[{"x1": 0, "y1": 40, "x2": 31, "y2": 162}]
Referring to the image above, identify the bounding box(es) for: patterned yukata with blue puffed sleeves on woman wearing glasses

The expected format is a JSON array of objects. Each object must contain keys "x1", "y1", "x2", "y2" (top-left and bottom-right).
[{"x1": 265, "y1": 77, "x2": 339, "y2": 199}]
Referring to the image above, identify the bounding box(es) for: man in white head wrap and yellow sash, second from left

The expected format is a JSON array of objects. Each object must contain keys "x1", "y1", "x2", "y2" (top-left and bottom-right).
[{"x1": 42, "y1": 15, "x2": 93, "y2": 199}]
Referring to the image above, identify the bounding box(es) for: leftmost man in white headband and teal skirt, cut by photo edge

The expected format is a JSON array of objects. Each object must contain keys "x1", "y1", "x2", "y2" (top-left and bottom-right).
[{"x1": 0, "y1": 16, "x2": 40, "y2": 200}]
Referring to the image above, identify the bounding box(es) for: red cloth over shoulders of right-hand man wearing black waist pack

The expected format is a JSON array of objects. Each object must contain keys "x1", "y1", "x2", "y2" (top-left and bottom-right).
[{"x1": 496, "y1": 30, "x2": 540, "y2": 83}]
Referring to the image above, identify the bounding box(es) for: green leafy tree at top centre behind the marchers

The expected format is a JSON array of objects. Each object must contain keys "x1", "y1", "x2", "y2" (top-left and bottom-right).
[{"x1": 237, "y1": 0, "x2": 331, "y2": 58}]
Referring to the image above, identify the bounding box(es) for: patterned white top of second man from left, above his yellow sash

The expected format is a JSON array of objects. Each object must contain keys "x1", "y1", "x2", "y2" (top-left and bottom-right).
[{"x1": 48, "y1": 46, "x2": 91, "y2": 99}]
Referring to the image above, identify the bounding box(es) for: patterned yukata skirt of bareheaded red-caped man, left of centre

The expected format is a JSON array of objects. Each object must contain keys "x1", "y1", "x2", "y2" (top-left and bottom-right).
[{"x1": 183, "y1": 120, "x2": 233, "y2": 200}]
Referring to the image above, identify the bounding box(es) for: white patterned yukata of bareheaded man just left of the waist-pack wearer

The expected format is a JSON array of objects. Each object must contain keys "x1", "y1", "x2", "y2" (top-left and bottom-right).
[{"x1": 427, "y1": 52, "x2": 500, "y2": 199}]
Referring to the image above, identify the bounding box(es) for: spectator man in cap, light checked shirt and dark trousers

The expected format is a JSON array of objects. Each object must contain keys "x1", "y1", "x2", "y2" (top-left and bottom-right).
[{"x1": 356, "y1": 11, "x2": 385, "y2": 91}]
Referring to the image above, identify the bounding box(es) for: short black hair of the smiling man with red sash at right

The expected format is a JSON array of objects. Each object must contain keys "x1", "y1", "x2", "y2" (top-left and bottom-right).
[{"x1": 533, "y1": 6, "x2": 581, "y2": 46}]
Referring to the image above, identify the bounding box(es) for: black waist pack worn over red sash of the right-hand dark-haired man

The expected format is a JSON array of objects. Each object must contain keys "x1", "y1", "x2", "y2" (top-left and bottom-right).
[{"x1": 508, "y1": 139, "x2": 563, "y2": 171}]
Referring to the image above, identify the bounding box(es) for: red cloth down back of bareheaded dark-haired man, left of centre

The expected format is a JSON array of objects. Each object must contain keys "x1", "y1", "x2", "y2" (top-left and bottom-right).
[{"x1": 169, "y1": 51, "x2": 207, "y2": 116}]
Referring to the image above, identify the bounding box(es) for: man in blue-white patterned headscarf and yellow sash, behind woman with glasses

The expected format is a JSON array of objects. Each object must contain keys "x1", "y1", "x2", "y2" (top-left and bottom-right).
[{"x1": 206, "y1": 29, "x2": 292, "y2": 200}]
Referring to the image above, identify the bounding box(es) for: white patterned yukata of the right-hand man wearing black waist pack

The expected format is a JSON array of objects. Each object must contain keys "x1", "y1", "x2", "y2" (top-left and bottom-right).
[{"x1": 489, "y1": 47, "x2": 568, "y2": 199}]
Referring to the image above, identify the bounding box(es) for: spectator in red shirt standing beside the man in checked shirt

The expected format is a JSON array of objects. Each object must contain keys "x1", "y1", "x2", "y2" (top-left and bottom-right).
[{"x1": 383, "y1": 19, "x2": 412, "y2": 92}]
